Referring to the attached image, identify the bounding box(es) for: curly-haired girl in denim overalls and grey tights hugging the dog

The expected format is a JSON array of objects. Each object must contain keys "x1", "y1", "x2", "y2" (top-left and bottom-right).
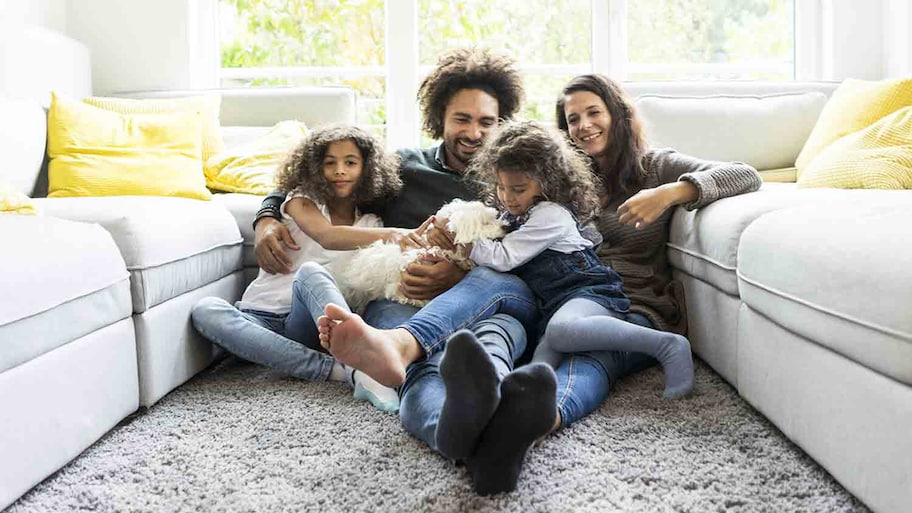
[{"x1": 456, "y1": 121, "x2": 694, "y2": 398}]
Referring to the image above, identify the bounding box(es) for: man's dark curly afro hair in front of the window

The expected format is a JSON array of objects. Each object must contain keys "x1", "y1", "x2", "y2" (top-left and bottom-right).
[{"x1": 418, "y1": 48, "x2": 524, "y2": 139}]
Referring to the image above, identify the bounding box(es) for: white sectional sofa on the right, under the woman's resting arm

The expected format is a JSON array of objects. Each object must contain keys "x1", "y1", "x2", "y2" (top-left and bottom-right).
[{"x1": 627, "y1": 83, "x2": 912, "y2": 512}]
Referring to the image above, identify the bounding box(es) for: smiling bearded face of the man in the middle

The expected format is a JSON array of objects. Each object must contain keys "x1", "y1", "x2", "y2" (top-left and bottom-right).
[{"x1": 443, "y1": 89, "x2": 499, "y2": 171}]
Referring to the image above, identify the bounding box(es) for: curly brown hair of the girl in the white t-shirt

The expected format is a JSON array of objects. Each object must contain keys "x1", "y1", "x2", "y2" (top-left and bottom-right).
[{"x1": 276, "y1": 125, "x2": 402, "y2": 205}]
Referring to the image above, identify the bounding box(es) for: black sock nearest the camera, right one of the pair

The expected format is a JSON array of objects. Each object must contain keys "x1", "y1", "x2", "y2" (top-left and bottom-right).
[{"x1": 466, "y1": 363, "x2": 557, "y2": 495}]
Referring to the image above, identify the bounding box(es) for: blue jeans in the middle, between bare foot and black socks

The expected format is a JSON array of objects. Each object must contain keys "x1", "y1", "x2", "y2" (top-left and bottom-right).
[{"x1": 356, "y1": 267, "x2": 538, "y2": 451}]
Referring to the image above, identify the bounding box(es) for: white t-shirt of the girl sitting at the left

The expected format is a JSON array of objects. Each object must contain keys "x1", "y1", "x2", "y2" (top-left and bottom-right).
[{"x1": 237, "y1": 191, "x2": 383, "y2": 314}]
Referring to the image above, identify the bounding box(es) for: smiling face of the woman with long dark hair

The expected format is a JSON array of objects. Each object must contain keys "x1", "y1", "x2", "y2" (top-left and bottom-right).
[{"x1": 564, "y1": 91, "x2": 611, "y2": 158}]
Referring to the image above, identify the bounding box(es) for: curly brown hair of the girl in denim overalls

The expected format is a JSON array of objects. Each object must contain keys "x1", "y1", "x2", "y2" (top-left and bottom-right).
[{"x1": 469, "y1": 121, "x2": 599, "y2": 224}]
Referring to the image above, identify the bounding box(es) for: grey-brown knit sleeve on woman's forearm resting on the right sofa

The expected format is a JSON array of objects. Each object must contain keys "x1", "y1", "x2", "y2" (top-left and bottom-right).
[{"x1": 646, "y1": 149, "x2": 762, "y2": 210}]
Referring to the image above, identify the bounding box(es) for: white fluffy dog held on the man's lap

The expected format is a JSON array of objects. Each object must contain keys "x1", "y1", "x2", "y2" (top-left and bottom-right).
[{"x1": 336, "y1": 199, "x2": 504, "y2": 312}]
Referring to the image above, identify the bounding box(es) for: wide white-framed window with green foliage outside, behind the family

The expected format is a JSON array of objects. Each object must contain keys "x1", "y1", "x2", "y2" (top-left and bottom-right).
[{"x1": 218, "y1": 0, "x2": 796, "y2": 147}]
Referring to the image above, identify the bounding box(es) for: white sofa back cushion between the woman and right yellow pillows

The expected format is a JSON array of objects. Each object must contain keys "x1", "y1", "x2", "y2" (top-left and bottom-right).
[{"x1": 623, "y1": 81, "x2": 838, "y2": 171}]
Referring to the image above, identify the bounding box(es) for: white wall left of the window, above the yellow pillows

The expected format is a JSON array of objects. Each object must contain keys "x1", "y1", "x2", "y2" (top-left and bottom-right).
[{"x1": 66, "y1": 0, "x2": 217, "y2": 94}]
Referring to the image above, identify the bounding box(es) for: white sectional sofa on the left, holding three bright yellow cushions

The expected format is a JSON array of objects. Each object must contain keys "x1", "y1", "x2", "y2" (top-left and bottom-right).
[{"x1": 0, "y1": 27, "x2": 356, "y2": 509}]
